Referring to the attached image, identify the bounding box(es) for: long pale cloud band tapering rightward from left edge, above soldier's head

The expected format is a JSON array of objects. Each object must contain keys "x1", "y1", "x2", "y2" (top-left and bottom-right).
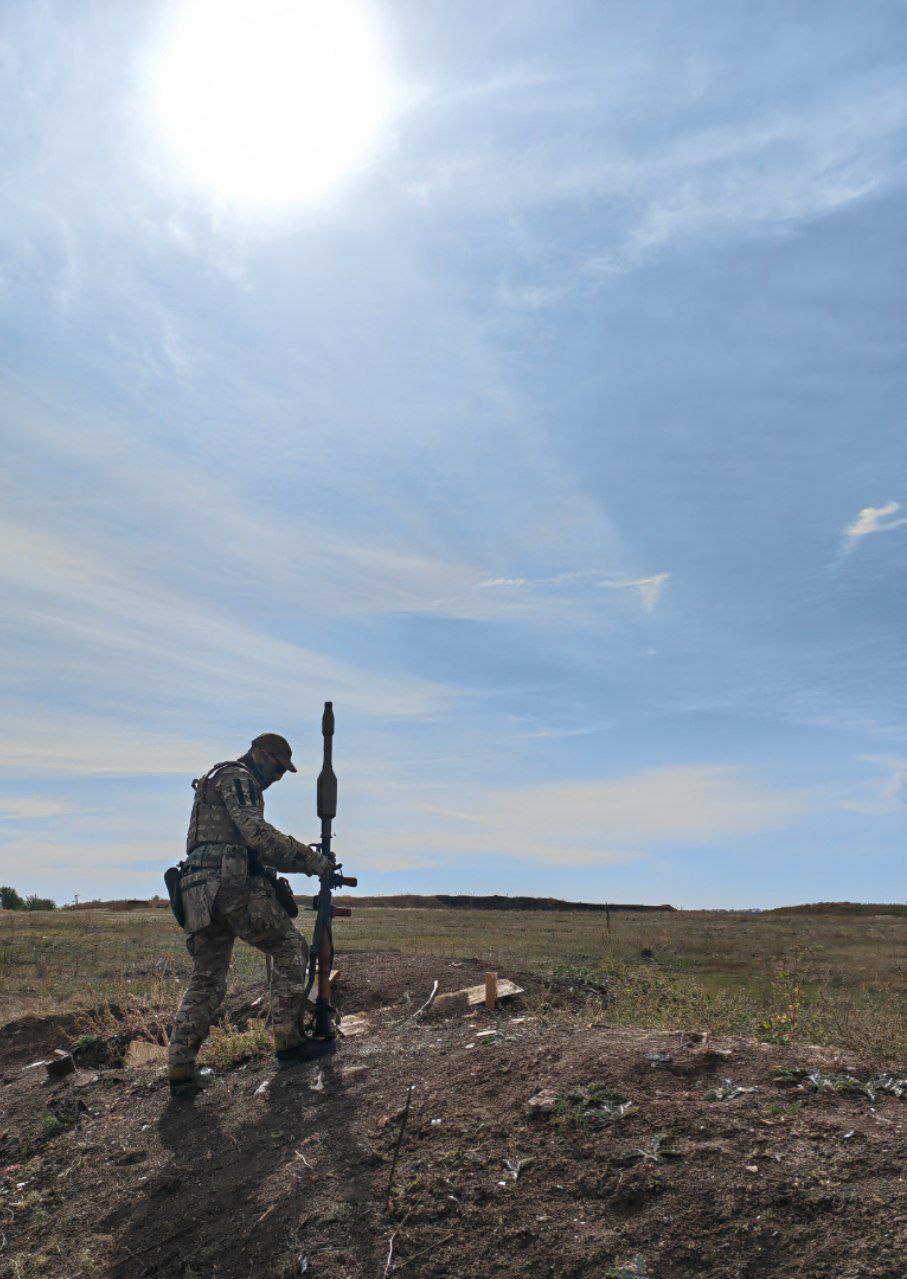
[{"x1": 0, "y1": 521, "x2": 450, "y2": 739}]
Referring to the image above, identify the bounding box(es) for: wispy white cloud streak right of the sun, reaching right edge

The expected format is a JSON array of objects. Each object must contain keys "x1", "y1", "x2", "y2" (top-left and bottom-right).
[{"x1": 401, "y1": 68, "x2": 907, "y2": 269}]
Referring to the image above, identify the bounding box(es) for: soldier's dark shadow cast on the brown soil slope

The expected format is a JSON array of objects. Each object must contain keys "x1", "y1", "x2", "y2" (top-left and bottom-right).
[{"x1": 105, "y1": 1059, "x2": 375, "y2": 1279}]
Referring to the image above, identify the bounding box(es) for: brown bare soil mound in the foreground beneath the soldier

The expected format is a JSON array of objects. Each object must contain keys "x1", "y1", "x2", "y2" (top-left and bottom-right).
[{"x1": 0, "y1": 953, "x2": 907, "y2": 1279}]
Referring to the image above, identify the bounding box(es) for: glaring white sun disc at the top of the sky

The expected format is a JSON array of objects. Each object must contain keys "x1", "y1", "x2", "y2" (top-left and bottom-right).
[{"x1": 151, "y1": 0, "x2": 390, "y2": 208}]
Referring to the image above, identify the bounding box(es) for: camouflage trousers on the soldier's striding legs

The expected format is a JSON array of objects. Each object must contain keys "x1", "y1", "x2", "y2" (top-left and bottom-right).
[{"x1": 168, "y1": 877, "x2": 308, "y2": 1077}]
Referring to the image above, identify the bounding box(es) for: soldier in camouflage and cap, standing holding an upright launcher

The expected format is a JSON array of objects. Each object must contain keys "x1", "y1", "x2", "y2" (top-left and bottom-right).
[{"x1": 168, "y1": 733, "x2": 331, "y2": 1096}]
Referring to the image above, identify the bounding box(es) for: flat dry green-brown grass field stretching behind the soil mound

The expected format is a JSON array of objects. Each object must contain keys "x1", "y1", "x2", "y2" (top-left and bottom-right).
[{"x1": 0, "y1": 907, "x2": 907, "y2": 1065}]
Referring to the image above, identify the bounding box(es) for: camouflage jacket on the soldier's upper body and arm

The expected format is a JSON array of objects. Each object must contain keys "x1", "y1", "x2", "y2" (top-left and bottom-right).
[{"x1": 185, "y1": 760, "x2": 327, "y2": 875}]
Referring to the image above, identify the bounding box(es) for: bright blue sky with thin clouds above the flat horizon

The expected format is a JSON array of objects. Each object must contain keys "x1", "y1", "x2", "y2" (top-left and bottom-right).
[{"x1": 0, "y1": 0, "x2": 907, "y2": 908}]
